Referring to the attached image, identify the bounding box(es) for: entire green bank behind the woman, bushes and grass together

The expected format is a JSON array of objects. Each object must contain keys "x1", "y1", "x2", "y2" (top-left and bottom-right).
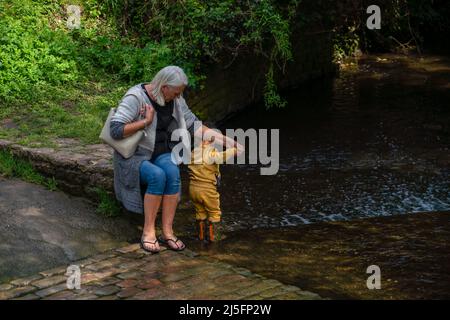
[{"x1": 0, "y1": 0, "x2": 299, "y2": 121}]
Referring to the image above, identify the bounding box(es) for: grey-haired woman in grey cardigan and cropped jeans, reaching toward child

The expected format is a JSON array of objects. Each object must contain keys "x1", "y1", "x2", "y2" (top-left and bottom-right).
[{"x1": 110, "y1": 66, "x2": 234, "y2": 253}]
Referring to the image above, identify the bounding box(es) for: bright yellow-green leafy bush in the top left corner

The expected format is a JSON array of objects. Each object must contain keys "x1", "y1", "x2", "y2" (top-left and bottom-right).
[{"x1": 0, "y1": 0, "x2": 78, "y2": 99}]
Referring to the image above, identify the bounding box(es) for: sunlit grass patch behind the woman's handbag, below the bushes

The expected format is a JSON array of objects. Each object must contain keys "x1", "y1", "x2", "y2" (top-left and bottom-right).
[{"x1": 0, "y1": 81, "x2": 128, "y2": 147}]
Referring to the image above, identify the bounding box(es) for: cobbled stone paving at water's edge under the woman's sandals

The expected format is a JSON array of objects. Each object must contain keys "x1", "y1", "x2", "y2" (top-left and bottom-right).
[{"x1": 0, "y1": 244, "x2": 320, "y2": 300}]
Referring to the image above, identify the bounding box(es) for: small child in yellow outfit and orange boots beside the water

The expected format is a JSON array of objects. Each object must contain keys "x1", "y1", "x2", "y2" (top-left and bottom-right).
[{"x1": 188, "y1": 137, "x2": 237, "y2": 242}]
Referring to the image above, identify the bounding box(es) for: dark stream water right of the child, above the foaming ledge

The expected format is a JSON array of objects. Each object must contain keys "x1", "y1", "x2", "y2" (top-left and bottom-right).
[{"x1": 179, "y1": 55, "x2": 450, "y2": 231}]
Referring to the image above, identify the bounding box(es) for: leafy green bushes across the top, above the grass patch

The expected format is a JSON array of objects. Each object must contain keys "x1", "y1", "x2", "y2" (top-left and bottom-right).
[{"x1": 0, "y1": 0, "x2": 299, "y2": 106}]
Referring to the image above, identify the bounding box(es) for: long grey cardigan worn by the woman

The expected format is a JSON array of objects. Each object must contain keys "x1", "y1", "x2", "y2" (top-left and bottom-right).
[{"x1": 111, "y1": 83, "x2": 198, "y2": 214}]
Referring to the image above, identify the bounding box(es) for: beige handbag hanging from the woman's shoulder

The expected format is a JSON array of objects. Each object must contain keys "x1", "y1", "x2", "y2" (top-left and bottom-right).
[{"x1": 99, "y1": 108, "x2": 147, "y2": 158}]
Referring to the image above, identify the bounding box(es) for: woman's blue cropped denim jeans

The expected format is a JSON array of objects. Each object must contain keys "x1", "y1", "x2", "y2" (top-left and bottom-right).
[{"x1": 139, "y1": 152, "x2": 181, "y2": 195}]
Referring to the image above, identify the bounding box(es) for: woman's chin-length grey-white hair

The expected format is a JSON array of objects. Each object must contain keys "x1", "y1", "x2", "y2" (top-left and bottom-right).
[{"x1": 151, "y1": 66, "x2": 188, "y2": 106}]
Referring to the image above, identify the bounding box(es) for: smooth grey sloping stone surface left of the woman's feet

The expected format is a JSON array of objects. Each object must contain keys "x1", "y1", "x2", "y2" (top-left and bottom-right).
[{"x1": 0, "y1": 178, "x2": 139, "y2": 282}]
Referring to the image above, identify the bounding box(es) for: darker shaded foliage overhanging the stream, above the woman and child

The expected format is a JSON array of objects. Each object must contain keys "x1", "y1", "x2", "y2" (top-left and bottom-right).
[{"x1": 106, "y1": 0, "x2": 300, "y2": 106}]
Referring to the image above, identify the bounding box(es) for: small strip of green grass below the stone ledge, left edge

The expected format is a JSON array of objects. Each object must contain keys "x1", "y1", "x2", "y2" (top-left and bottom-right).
[{"x1": 0, "y1": 150, "x2": 57, "y2": 190}]
